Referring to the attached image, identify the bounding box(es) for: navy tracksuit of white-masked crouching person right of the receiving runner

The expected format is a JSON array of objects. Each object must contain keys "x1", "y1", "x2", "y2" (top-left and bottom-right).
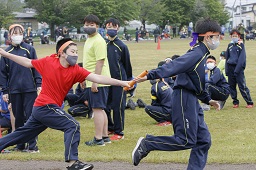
[{"x1": 205, "y1": 67, "x2": 230, "y2": 101}]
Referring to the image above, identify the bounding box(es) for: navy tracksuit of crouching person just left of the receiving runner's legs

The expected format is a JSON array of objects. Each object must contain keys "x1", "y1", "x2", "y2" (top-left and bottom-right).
[{"x1": 145, "y1": 78, "x2": 173, "y2": 123}]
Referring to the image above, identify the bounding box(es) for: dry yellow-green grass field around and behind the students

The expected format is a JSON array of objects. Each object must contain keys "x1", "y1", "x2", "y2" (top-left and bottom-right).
[{"x1": 0, "y1": 39, "x2": 256, "y2": 164}]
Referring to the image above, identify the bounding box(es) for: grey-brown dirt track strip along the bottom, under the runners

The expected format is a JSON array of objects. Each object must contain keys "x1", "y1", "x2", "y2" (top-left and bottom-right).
[{"x1": 0, "y1": 160, "x2": 256, "y2": 170}]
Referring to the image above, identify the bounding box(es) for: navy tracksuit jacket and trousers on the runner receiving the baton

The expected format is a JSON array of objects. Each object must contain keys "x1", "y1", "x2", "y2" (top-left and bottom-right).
[{"x1": 145, "y1": 42, "x2": 211, "y2": 170}]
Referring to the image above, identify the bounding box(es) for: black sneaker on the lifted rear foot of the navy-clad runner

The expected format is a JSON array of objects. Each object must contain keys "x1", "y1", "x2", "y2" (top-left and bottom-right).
[{"x1": 132, "y1": 137, "x2": 149, "y2": 166}]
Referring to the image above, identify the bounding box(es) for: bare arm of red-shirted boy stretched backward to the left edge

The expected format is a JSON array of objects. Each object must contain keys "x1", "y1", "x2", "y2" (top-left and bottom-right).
[{"x1": 0, "y1": 48, "x2": 33, "y2": 68}]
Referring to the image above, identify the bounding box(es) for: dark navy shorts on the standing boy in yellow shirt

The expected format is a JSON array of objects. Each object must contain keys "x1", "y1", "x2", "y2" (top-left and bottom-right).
[{"x1": 89, "y1": 86, "x2": 108, "y2": 109}]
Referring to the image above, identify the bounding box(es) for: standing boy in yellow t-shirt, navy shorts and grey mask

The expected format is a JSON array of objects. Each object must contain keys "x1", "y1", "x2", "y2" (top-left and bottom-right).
[{"x1": 83, "y1": 14, "x2": 111, "y2": 146}]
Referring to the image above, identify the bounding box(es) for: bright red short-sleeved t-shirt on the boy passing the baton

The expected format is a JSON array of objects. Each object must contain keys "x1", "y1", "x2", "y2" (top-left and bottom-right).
[{"x1": 31, "y1": 54, "x2": 90, "y2": 106}]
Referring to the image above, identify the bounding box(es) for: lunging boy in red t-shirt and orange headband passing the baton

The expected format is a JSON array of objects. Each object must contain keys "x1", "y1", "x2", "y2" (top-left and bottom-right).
[{"x1": 0, "y1": 38, "x2": 129, "y2": 170}]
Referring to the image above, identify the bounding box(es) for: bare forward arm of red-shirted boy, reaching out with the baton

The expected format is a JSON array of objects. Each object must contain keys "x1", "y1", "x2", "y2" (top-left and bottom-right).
[{"x1": 86, "y1": 73, "x2": 130, "y2": 87}]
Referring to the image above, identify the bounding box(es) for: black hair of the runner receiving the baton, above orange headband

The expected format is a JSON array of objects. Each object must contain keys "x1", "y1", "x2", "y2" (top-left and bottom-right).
[{"x1": 195, "y1": 18, "x2": 221, "y2": 42}]
